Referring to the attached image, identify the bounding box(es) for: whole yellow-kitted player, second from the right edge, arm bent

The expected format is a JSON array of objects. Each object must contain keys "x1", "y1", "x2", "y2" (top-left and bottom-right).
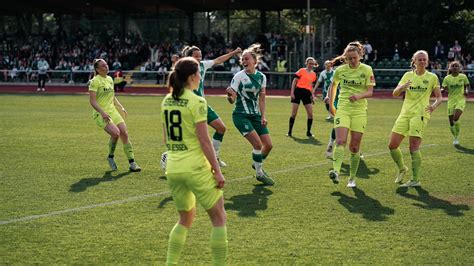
[{"x1": 388, "y1": 50, "x2": 442, "y2": 187}]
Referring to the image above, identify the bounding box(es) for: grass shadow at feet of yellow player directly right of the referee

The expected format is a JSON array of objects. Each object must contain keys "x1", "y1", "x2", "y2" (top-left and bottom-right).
[{"x1": 331, "y1": 188, "x2": 395, "y2": 221}]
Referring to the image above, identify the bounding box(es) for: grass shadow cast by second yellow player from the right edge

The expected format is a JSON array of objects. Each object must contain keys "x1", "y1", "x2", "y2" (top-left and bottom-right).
[{"x1": 397, "y1": 187, "x2": 470, "y2": 216}]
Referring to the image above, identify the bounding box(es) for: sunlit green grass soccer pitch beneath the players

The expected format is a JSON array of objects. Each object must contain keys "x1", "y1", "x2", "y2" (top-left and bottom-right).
[{"x1": 0, "y1": 95, "x2": 474, "y2": 265}]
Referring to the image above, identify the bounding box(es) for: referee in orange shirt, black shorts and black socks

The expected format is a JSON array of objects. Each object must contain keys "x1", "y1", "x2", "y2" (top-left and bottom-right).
[{"x1": 287, "y1": 57, "x2": 318, "y2": 137}]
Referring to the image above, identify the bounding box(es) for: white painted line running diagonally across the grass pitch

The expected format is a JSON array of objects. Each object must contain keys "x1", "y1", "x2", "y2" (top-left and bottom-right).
[{"x1": 0, "y1": 144, "x2": 440, "y2": 225}]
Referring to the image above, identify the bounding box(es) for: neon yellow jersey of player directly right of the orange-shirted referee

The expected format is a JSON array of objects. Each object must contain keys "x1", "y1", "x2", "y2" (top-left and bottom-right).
[{"x1": 333, "y1": 63, "x2": 375, "y2": 111}]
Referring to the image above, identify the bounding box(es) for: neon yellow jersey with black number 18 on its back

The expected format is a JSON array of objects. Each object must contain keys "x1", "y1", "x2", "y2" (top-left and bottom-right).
[{"x1": 161, "y1": 89, "x2": 211, "y2": 174}]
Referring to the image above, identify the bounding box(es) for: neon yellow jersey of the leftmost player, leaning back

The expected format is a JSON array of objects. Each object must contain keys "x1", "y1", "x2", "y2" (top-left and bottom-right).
[{"x1": 89, "y1": 75, "x2": 115, "y2": 112}]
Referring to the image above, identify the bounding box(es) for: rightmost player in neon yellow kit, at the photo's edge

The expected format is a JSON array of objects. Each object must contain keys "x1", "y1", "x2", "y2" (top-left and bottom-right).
[{"x1": 442, "y1": 61, "x2": 469, "y2": 145}]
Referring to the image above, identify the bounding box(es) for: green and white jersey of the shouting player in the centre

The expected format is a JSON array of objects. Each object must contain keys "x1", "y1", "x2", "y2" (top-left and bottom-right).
[{"x1": 230, "y1": 70, "x2": 267, "y2": 115}]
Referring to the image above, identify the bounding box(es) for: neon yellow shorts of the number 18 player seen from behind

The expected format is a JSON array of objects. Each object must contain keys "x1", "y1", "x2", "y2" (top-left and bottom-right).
[{"x1": 166, "y1": 170, "x2": 223, "y2": 211}]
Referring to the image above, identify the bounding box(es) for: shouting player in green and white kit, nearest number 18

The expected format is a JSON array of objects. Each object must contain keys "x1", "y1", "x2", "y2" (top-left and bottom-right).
[{"x1": 227, "y1": 44, "x2": 275, "y2": 186}]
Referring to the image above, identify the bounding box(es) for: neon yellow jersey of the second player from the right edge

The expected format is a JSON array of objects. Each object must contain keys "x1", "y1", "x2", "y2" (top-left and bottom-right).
[{"x1": 398, "y1": 71, "x2": 439, "y2": 118}]
